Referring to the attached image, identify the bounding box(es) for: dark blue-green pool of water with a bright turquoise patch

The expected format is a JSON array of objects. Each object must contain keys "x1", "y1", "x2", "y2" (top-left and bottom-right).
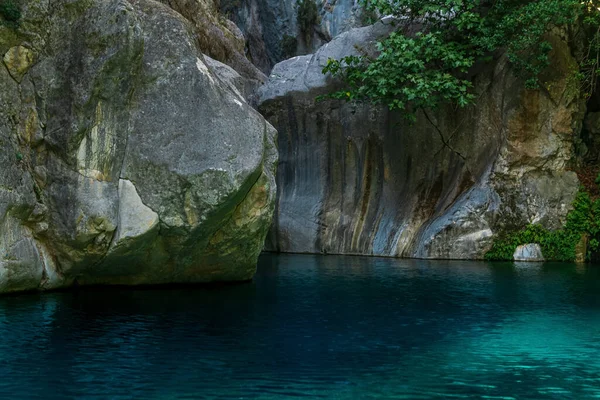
[{"x1": 0, "y1": 255, "x2": 600, "y2": 399}]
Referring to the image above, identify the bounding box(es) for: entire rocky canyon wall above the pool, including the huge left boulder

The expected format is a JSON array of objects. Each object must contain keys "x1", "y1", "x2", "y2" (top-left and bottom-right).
[{"x1": 0, "y1": 0, "x2": 600, "y2": 292}]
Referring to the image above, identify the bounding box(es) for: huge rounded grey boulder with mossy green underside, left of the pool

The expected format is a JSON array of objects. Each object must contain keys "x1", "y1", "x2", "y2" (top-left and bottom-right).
[{"x1": 0, "y1": 0, "x2": 277, "y2": 292}]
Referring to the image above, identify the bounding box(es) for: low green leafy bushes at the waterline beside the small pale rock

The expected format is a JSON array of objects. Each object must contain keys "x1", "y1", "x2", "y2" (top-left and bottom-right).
[{"x1": 485, "y1": 190, "x2": 600, "y2": 261}]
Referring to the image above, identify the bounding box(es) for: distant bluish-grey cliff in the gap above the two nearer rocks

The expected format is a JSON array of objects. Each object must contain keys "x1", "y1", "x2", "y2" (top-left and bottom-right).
[{"x1": 221, "y1": 0, "x2": 367, "y2": 73}]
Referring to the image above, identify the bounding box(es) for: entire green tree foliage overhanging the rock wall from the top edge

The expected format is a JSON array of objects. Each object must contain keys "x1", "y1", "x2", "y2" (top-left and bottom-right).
[{"x1": 323, "y1": 0, "x2": 600, "y2": 118}]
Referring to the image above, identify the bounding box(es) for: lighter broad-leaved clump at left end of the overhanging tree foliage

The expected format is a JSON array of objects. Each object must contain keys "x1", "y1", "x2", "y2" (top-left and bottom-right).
[{"x1": 324, "y1": 32, "x2": 474, "y2": 120}]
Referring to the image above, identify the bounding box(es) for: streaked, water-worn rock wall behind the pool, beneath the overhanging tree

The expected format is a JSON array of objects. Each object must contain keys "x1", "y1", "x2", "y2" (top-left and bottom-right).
[{"x1": 260, "y1": 23, "x2": 580, "y2": 259}]
